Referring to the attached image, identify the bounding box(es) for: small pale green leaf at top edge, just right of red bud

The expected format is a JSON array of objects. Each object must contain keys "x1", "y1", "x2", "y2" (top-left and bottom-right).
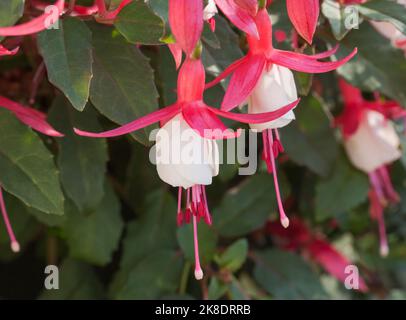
[{"x1": 321, "y1": 0, "x2": 351, "y2": 40}]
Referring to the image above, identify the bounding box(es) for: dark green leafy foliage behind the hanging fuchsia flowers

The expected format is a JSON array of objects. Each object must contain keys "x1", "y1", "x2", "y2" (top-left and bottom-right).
[{"x1": 0, "y1": 0, "x2": 406, "y2": 299}]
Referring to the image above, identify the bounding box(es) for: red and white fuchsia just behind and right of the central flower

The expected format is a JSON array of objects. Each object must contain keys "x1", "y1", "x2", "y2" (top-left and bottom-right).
[{"x1": 207, "y1": 9, "x2": 357, "y2": 227}]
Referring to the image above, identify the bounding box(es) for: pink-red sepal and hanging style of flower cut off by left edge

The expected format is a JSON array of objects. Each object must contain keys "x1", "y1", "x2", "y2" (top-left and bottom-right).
[{"x1": 0, "y1": 96, "x2": 63, "y2": 252}]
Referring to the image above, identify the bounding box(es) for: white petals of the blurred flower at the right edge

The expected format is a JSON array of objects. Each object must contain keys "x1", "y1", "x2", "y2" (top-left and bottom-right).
[{"x1": 344, "y1": 111, "x2": 402, "y2": 173}]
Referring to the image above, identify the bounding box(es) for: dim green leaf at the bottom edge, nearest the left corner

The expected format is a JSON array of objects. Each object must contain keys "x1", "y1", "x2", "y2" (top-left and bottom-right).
[{"x1": 39, "y1": 259, "x2": 104, "y2": 300}]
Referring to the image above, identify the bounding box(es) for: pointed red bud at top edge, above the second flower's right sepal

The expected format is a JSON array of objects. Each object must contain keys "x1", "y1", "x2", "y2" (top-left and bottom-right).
[{"x1": 286, "y1": 0, "x2": 320, "y2": 44}]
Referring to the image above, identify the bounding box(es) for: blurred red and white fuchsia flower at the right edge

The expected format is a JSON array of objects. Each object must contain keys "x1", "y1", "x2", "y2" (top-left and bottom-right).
[{"x1": 335, "y1": 79, "x2": 406, "y2": 256}]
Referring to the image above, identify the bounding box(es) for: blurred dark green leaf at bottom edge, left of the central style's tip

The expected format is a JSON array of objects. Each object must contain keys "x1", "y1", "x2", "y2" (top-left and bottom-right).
[{"x1": 111, "y1": 250, "x2": 183, "y2": 300}]
